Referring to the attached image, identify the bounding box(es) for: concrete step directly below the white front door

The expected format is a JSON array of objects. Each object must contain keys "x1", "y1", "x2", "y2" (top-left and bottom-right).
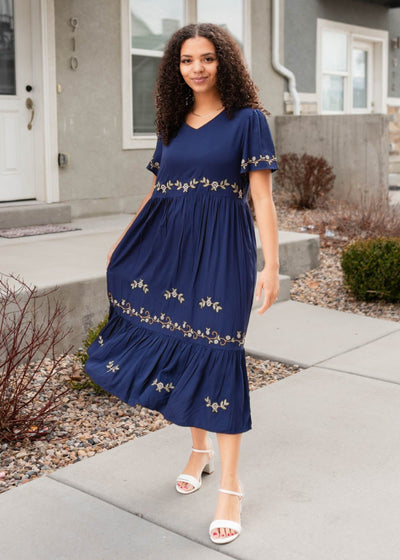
[{"x1": 0, "y1": 201, "x2": 71, "y2": 229}]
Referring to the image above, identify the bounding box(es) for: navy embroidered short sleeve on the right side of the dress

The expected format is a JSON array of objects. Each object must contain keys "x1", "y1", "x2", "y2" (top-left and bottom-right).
[{"x1": 240, "y1": 109, "x2": 278, "y2": 173}]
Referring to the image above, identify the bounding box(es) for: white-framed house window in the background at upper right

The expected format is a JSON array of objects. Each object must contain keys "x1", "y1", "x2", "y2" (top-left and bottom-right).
[{"x1": 317, "y1": 20, "x2": 388, "y2": 114}]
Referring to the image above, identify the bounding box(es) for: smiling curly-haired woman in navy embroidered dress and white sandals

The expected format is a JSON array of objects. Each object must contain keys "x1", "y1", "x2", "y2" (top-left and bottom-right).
[{"x1": 86, "y1": 24, "x2": 279, "y2": 543}]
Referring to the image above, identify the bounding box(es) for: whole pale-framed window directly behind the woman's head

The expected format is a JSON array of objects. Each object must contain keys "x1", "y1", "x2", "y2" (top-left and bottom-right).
[{"x1": 121, "y1": 0, "x2": 249, "y2": 149}]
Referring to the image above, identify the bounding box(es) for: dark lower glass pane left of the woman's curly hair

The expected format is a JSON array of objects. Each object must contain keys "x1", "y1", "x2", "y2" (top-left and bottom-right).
[{"x1": 132, "y1": 55, "x2": 161, "y2": 134}]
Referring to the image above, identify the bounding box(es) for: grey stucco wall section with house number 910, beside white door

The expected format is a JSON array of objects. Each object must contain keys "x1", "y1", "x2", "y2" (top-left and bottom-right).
[{"x1": 55, "y1": 0, "x2": 153, "y2": 216}]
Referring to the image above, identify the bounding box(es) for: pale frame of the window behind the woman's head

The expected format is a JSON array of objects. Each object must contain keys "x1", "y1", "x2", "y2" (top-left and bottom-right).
[{"x1": 121, "y1": 0, "x2": 251, "y2": 150}]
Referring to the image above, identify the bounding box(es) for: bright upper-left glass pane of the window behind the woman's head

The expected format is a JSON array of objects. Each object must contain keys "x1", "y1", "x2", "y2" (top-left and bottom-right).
[{"x1": 130, "y1": 0, "x2": 185, "y2": 51}]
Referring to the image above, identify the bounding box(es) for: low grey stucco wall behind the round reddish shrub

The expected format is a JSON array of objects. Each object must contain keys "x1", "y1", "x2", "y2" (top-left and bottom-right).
[{"x1": 275, "y1": 114, "x2": 389, "y2": 203}]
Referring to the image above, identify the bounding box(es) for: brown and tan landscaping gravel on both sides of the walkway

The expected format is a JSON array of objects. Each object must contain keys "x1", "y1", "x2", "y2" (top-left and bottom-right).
[{"x1": 0, "y1": 199, "x2": 400, "y2": 493}]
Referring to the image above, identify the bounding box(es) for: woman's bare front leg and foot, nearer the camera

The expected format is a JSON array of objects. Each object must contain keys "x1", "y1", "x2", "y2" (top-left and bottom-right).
[{"x1": 213, "y1": 434, "x2": 242, "y2": 538}]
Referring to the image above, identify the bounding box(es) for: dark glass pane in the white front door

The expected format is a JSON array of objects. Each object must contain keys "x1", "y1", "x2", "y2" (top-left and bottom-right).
[{"x1": 0, "y1": 0, "x2": 16, "y2": 95}]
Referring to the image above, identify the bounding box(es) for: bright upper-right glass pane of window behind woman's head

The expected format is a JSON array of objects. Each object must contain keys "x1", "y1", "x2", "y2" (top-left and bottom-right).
[{"x1": 197, "y1": 0, "x2": 244, "y2": 50}]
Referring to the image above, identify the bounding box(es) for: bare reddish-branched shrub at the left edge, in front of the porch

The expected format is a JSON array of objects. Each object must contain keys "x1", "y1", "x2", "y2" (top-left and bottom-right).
[{"x1": 0, "y1": 273, "x2": 72, "y2": 441}]
